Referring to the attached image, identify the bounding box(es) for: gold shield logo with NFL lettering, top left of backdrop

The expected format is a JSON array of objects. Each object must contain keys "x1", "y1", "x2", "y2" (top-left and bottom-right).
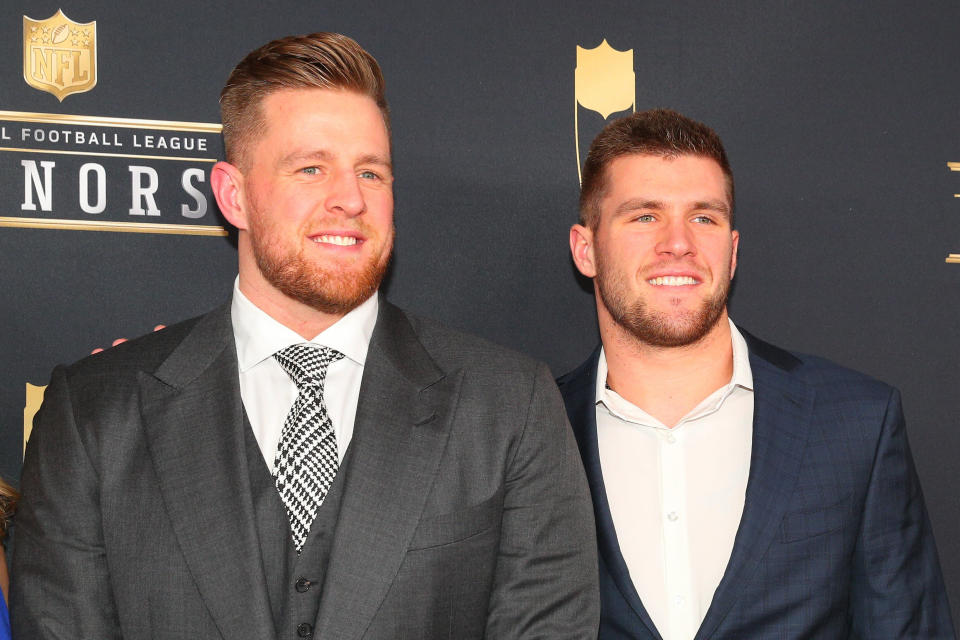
[{"x1": 23, "y1": 10, "x2": 97, "y2": 102}]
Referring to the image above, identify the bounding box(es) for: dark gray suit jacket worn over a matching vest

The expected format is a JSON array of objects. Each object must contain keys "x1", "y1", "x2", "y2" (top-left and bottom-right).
[{"x1": 12, "y1": 301, "x2": 599, "y2": 640}]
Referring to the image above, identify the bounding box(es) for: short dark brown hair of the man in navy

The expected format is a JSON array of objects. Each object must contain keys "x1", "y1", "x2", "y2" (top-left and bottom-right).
[{"x1": 580, "y1": 109, "x2": 733, "y2": 229}]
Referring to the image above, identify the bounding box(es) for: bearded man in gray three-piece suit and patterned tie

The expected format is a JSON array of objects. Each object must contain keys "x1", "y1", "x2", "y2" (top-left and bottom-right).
[{"x1": 12, "y1": 34, "x2": 599, "y2": 640}]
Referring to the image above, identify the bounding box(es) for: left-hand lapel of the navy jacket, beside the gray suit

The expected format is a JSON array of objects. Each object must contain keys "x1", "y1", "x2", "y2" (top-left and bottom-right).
[{"x1": 561, "y1": 348, "x2": 660, "y2": 640}]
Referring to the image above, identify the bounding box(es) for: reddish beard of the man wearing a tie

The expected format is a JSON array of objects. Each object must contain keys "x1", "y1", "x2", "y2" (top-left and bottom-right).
[{"x1": 249, "y1": 215, "x2": 394, "y2": 315}]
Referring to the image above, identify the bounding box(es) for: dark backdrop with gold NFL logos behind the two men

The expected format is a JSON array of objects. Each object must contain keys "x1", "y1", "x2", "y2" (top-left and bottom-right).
[{"x1": 0, "y1": 0, "x2": 960, "y2": 619}]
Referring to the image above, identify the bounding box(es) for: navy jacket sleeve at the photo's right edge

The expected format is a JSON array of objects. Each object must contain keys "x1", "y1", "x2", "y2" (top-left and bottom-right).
[{"x1": 850, "y1": 390, "x2": 955, "y2": 640}]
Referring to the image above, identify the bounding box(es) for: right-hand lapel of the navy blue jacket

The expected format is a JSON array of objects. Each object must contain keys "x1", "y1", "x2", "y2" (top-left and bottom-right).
[{"x1": 696, "y1": 332, "x2": 814, "y2": 640}]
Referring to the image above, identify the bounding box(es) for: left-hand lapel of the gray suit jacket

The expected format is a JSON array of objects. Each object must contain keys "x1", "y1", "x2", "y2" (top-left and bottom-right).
[{"x1": 140, "y1": 306, "x2": 276, "y2": 640}]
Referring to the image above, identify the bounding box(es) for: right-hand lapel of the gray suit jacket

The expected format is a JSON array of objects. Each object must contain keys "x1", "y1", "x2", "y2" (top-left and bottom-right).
[{"x1": 316, "y1": 300, "x2": 461, "y2": 640}]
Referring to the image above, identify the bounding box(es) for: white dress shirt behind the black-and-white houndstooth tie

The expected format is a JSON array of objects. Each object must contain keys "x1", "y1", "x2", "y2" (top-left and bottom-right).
[{"x1": 230, "y1": 279, "x2": 379, "y2": 473}]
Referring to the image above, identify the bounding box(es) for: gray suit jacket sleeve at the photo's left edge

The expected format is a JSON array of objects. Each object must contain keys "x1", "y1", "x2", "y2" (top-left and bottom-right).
[{"x1": 10, "y1": 367, "x2": 120, "y2": 640}]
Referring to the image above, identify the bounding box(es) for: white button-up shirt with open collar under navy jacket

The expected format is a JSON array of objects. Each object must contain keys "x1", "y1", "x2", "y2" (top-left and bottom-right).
[{"x1": 596, "y1": 321, "x2": 753, "y2": 640}]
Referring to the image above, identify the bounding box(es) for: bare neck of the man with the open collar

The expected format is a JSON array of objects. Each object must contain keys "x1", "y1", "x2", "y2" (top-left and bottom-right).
[{"x1": 600, "y1": 311, "x2": 733, "y2": 427}]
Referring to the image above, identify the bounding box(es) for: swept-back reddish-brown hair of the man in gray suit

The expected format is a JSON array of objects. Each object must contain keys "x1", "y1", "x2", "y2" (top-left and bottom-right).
[{"x1": 220, "y1": 33, "x2": 390, "y2": 164}]
